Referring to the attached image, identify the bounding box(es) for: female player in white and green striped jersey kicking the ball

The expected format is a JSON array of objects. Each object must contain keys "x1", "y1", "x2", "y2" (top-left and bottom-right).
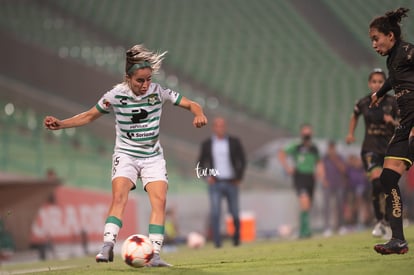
[{"x1": 44, "y1": 45, "x2": 207, "y2": 266}]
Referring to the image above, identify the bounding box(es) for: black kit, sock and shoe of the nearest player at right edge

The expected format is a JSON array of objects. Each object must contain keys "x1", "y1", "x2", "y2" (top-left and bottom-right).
[{"x1": 374, "y1": 40, "x2": 414, "y2": 254}]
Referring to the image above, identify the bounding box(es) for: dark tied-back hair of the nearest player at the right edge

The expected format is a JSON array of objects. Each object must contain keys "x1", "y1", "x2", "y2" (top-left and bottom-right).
[{"x1": 369, "y1": 8, "x2": 409, "y2": 40}]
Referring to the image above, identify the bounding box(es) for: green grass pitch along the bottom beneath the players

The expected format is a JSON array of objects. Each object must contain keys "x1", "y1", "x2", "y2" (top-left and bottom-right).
[{"x1": 0, "y1": 226, "x2": 414, "y2": 275}]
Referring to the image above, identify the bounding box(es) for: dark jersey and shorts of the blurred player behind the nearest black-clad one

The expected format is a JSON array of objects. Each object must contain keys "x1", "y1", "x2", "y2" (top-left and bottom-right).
[{"x1": 354, "y1": 95, "x2": 398, "y2": 172}]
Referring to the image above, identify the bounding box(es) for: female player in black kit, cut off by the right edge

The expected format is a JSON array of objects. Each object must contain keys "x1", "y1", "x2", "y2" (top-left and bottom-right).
[{"x1": 369, "y1": 8, "x2": 414, "y2": 254}]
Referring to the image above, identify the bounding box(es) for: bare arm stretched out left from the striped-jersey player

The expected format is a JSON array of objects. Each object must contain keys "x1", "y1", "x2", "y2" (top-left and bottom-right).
[{"x1": 43, "y1": 107, "x2": 102, "y2": 130}]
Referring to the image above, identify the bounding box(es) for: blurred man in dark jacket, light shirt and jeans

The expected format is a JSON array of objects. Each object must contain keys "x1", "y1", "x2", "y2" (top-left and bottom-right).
[{"x1": 197, "y1": 117, "x2": 246, "y2": 248}]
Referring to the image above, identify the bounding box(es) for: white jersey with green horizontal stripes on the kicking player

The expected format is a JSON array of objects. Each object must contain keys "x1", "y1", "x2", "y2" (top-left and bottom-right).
[{"x1": 96, "y1": 83, "x2": 181, "y2": 158}]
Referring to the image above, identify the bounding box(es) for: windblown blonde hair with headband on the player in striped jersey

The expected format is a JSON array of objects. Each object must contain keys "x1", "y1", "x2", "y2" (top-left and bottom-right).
[{"x1": 125, "y1": 44, "x2": 167, "y2": 76}]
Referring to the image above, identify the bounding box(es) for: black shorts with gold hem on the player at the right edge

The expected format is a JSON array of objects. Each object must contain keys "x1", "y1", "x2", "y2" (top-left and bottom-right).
[{"x1": 385, "y1": 123, "x2": 414, "y2": 169}]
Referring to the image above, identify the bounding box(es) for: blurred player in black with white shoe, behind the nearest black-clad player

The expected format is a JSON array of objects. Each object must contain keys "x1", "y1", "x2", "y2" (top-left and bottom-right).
[{"x1": 346, "y1": 69, "x2": 398, "y2": 238}]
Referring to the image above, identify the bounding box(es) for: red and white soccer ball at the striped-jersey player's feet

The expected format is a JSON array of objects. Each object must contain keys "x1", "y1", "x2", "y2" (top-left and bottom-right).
[{"x1": 121, "y1": 234, "x2": 154, "y2": 267}]
